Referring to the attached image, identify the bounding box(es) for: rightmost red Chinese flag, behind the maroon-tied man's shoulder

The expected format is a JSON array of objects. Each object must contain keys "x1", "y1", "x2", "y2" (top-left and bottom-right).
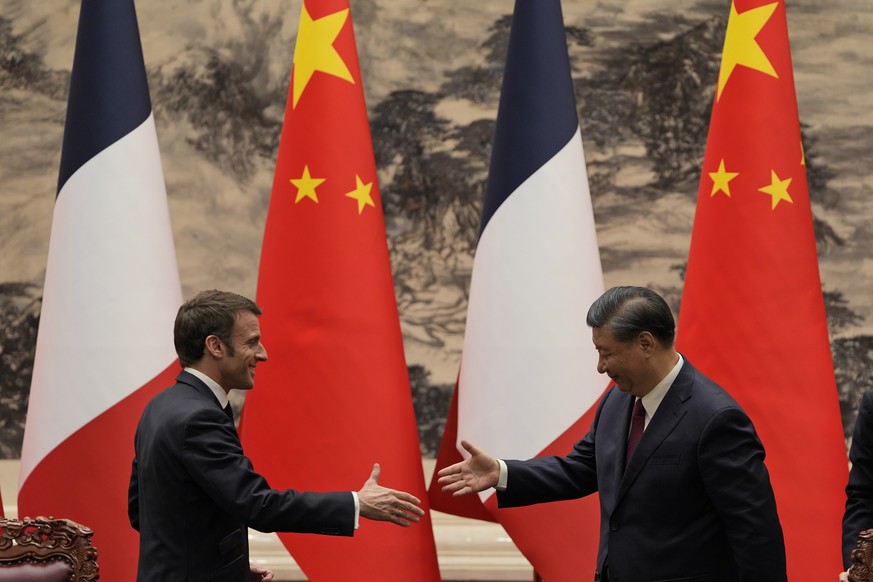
[{"x1": 677, "y1": 0, "x2": 847, "y2": 582}]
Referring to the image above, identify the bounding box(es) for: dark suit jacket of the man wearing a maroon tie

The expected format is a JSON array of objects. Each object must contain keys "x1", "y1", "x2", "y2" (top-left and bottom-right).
[{"x1": 498, "y1": 360, "x2": 787, "y2": 582}]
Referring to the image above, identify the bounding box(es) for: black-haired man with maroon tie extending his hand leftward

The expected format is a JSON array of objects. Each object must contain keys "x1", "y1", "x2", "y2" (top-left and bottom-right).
[{"x1": 439, "y1": 287, "x2": 787, "y2": 582}]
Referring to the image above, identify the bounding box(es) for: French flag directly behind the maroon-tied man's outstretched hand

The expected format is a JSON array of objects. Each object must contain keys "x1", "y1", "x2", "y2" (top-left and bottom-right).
[{"x1": 430, "y1": 0, "x2": 608, "y2": 582}]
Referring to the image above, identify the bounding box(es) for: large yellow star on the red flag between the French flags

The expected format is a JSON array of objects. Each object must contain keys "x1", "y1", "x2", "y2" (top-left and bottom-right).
[{"x1": 291, "y1": 2, "x2": 355, "y2": 108}]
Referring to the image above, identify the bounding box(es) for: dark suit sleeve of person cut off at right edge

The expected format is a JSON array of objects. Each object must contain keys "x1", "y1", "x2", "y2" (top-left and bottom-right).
[{"x1": 843, "y1": 390, "x2": 873, "y2": 568}]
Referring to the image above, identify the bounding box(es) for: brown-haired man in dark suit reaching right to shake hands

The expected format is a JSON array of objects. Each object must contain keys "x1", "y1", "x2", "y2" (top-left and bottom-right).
[{"x1": 128, "y1": 291, "x2": 424, "y2": 582}]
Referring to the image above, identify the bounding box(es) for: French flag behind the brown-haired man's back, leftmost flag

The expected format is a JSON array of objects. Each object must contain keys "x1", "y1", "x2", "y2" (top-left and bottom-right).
[{"x1": 18, "y1": 0, "x2": 182, "y2": 582}]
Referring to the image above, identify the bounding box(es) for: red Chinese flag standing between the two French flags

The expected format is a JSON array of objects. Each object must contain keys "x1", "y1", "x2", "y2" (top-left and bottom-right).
[{"x1": 241, "y1": 0, "x2": 439, "y2": 581}]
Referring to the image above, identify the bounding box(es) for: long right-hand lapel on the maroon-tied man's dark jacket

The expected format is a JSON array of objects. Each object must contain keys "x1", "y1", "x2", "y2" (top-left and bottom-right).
[{"x1": 618, "y1": 360, "x2": 694, "y2": 501}]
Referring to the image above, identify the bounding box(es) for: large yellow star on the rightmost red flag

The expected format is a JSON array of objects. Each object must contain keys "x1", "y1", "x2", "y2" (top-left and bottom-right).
[{"x1": 716, "y1": 2, "x2": 779, "y2": 101}]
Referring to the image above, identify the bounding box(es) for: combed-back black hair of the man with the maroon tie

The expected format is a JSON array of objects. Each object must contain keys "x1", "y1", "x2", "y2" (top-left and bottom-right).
[{"x1": 586, "y1": 287, "x2": 676, "y2": 347}]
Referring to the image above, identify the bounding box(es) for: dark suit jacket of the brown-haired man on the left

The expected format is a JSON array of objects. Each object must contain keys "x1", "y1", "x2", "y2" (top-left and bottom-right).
[{"x1": 128, "y1": 371, "x2": 355, "y2": 582}]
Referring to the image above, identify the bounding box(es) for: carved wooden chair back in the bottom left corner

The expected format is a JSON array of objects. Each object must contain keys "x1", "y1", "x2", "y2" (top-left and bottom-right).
[{"x1": 0, "y1": 517, "x2": 100, "y2": 582}]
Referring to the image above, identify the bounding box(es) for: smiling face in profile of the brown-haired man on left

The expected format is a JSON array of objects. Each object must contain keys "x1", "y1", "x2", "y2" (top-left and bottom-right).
[{"x1": 214, "y1": 311, "x2": 267, "y2": 392}]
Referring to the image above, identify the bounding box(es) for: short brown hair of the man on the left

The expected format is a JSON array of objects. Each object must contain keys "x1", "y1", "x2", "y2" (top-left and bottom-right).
[{"x1": 173, "y1": 289, "x2": 261, "y2": 367}]
